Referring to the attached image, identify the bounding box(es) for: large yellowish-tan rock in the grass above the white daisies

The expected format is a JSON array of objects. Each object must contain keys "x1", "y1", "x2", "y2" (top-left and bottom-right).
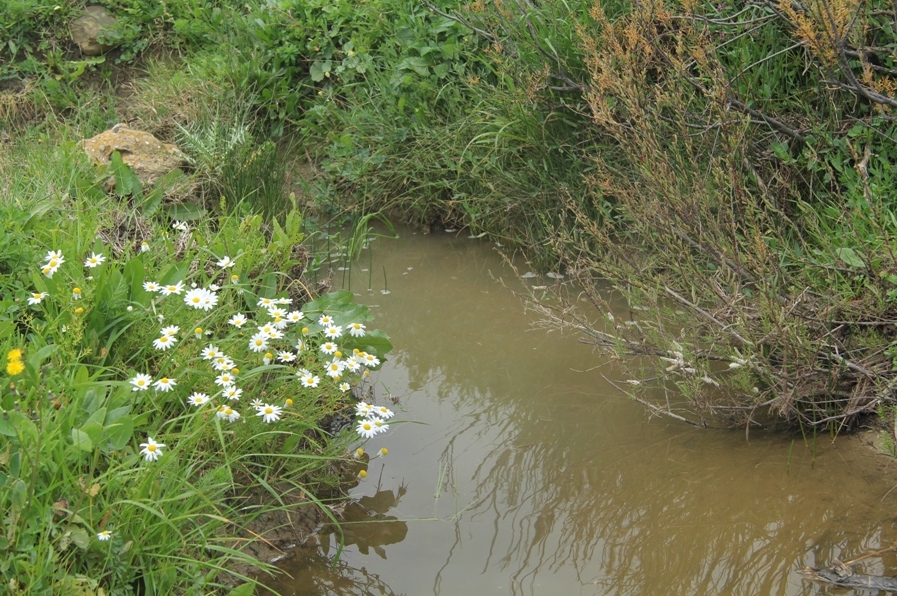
[{"x1": 81, "y1": 124, "x2": 187, "y2": 187}]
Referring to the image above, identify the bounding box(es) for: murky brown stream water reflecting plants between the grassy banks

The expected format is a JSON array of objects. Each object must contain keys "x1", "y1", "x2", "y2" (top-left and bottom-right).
[{"x1": 276, "y1": 230, "x2": 897, "y2": 596}]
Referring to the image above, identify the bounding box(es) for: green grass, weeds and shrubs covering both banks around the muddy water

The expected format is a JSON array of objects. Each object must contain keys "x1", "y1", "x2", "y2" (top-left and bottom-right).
[{"x1": 0, "y1": 0, "x2": 897, "y2": 593}]
